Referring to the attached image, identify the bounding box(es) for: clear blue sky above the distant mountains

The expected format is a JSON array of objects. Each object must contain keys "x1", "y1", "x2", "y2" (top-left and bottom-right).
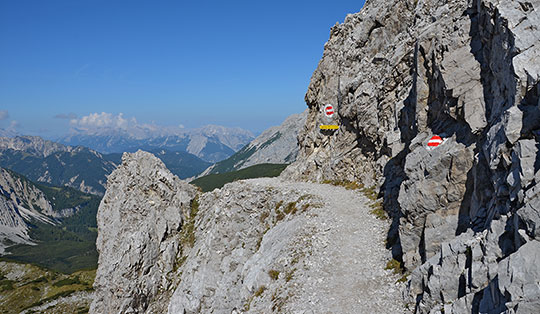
[{"x1": 0, "y1": 0, "x2": 364, "y2": 138}]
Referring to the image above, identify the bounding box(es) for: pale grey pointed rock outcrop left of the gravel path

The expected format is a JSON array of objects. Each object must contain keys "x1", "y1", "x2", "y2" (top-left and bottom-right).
[{"x1": 90, "y1": 151, "x2": 197, "y2": 313}]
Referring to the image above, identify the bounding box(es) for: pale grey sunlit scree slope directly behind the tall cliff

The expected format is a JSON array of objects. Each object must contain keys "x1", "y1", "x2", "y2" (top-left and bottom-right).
[{"x1": 201, "y1": 110, "x2": 307, "y2": 176}]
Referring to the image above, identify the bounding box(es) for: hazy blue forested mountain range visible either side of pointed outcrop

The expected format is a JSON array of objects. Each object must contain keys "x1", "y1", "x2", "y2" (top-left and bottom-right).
[{"x1": 0, "y1": 136, "x2": 210, "y2": 195}]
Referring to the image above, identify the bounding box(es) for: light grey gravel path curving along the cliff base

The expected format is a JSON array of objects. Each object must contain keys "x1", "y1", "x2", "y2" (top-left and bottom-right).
[{"x1": 249, "y1": 178, "x2": 408, "y2": 314}]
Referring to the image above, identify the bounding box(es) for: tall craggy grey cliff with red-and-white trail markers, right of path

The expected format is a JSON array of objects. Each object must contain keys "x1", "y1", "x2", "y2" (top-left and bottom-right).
[{"x1": 282, "y1": 0, "x2": 540, "y2": 313}]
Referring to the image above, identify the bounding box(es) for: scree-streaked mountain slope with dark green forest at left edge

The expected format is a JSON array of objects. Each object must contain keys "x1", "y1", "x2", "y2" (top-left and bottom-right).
[{"x1": 0, "y1": 168, "x2": 100, "y2": 272}]
